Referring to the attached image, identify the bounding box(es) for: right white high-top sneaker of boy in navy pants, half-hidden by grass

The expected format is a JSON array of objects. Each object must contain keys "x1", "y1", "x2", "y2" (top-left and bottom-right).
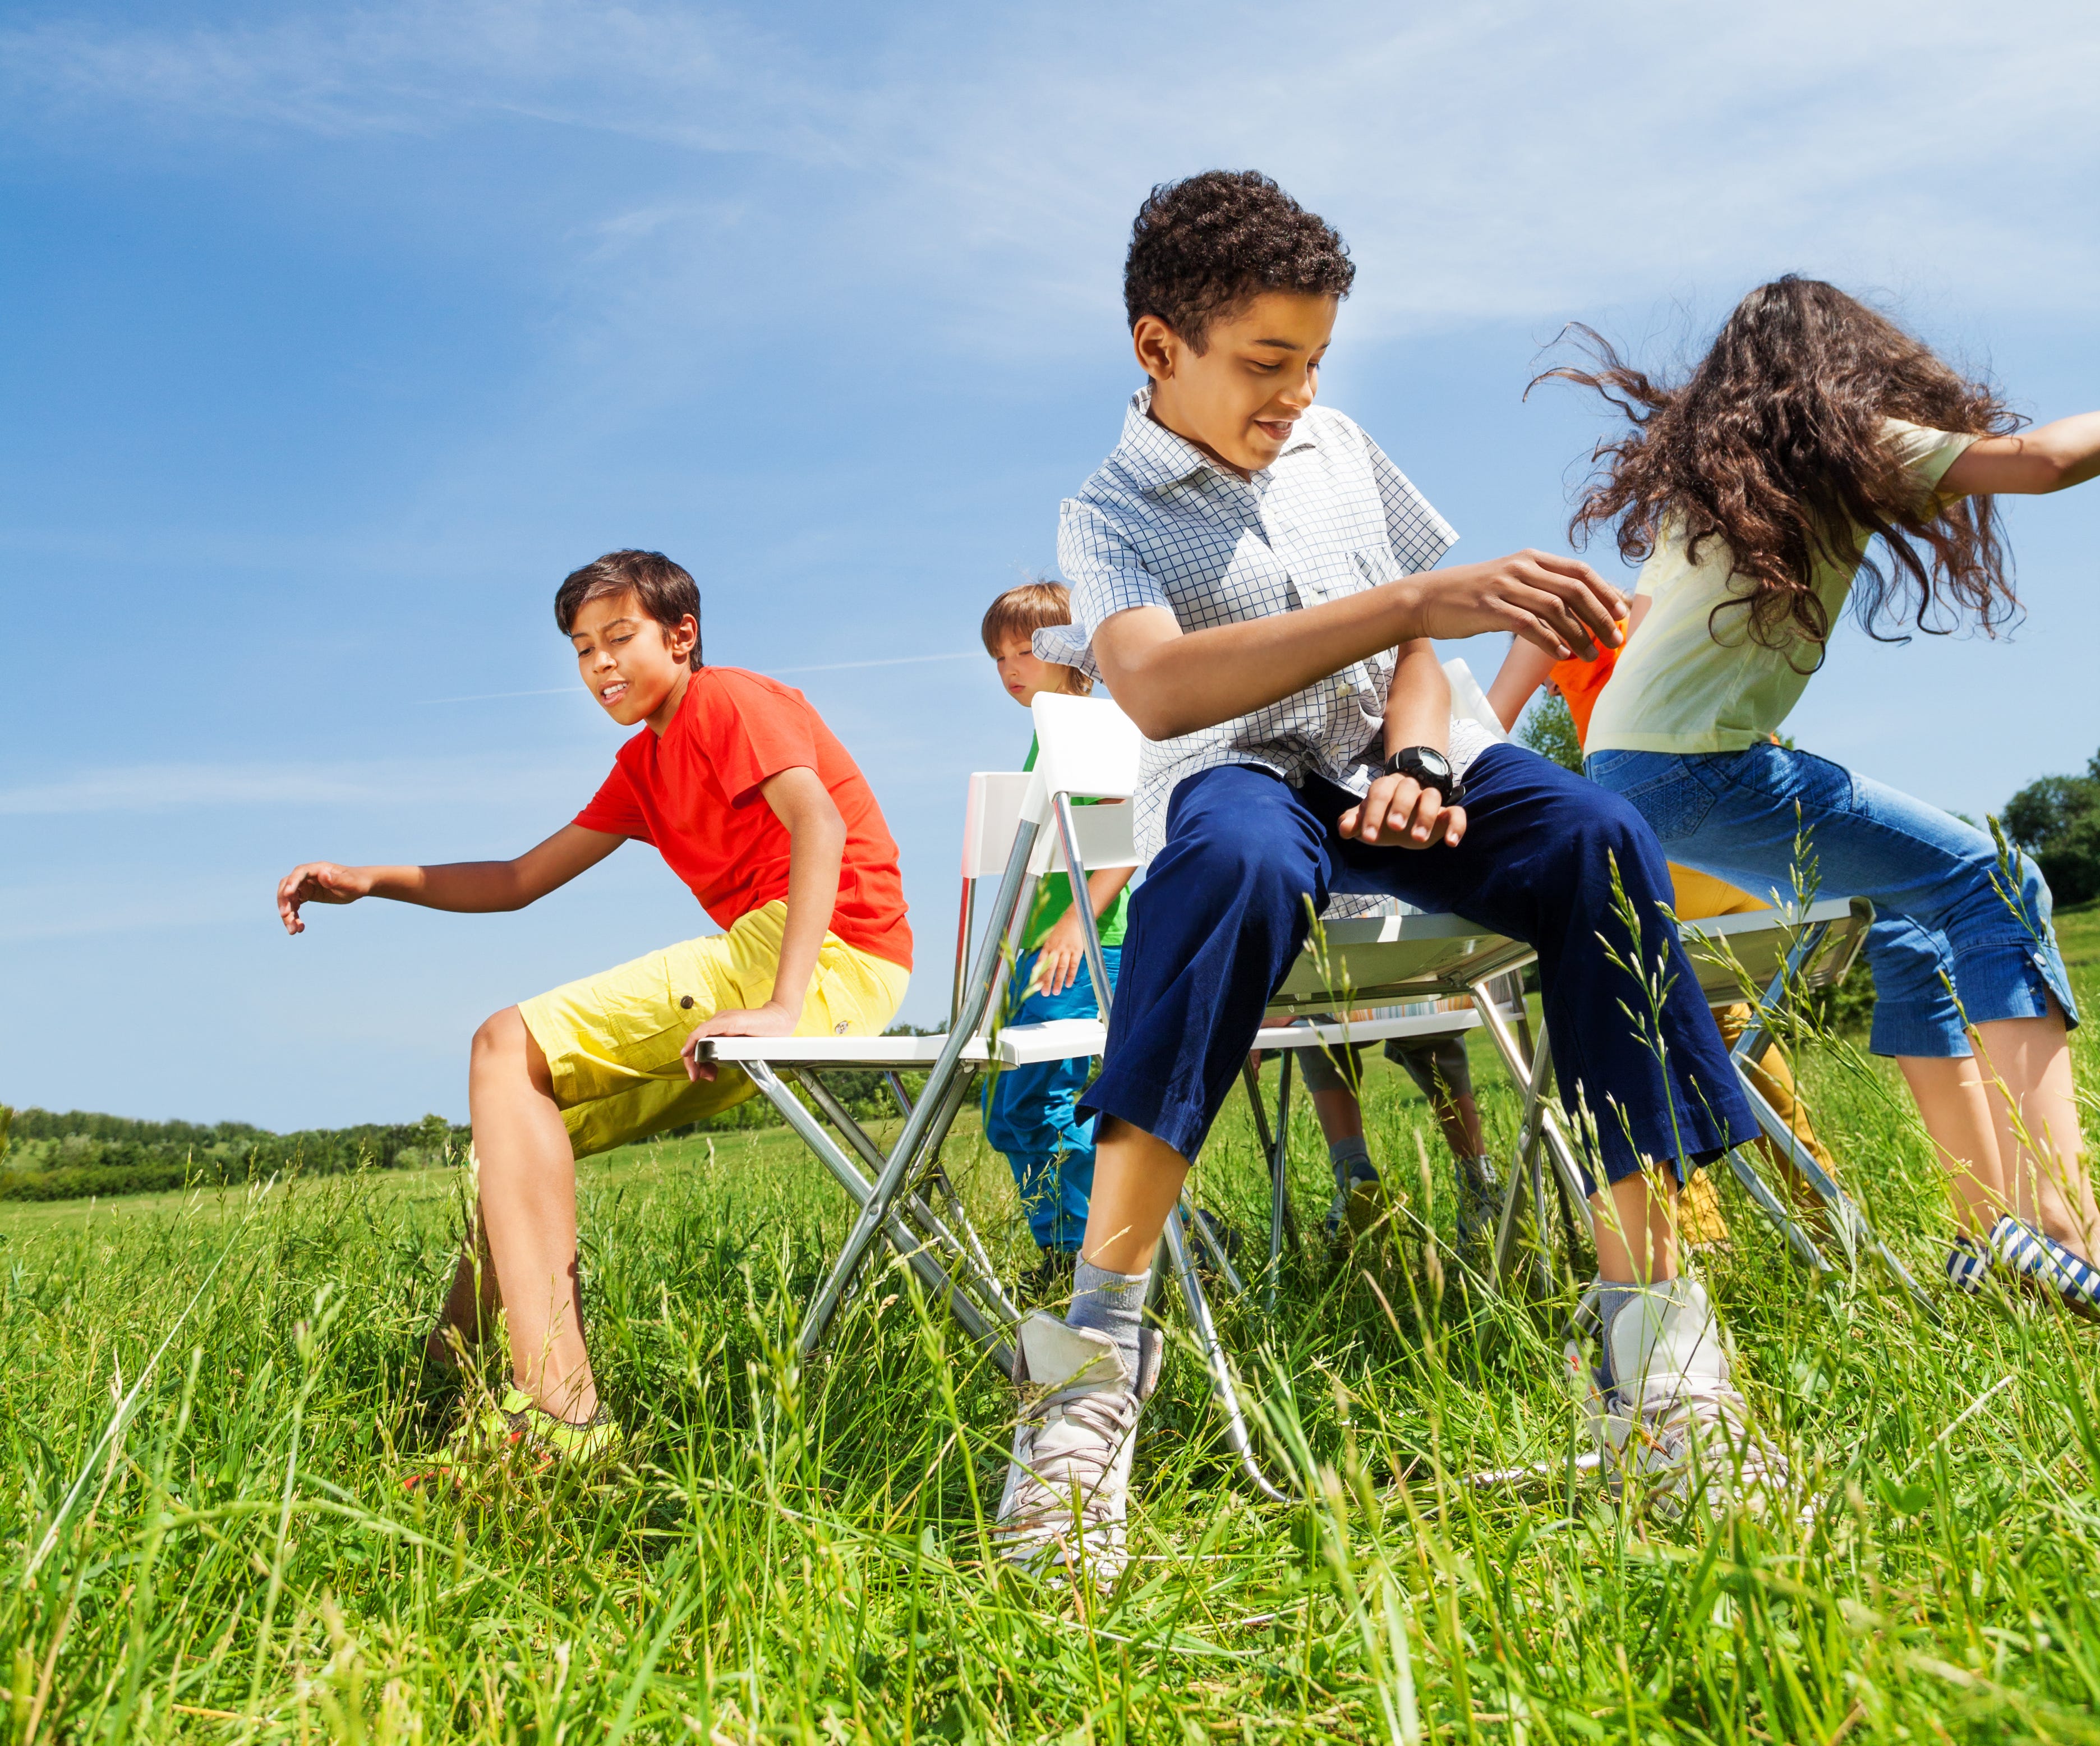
[{"x1": 1567, "y1": 1278, "x2": 1792, "y2": 1519}]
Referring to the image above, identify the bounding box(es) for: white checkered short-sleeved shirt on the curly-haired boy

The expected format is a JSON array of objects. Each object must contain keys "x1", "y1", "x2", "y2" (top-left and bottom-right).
[{"x1": 1035, "y1": 384, "x2": 1491, "y2": 860}]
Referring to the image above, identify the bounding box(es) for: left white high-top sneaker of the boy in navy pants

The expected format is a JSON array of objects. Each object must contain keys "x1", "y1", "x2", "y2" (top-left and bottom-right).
[{"x1": 991, "y1": 1309, "x2": 1161, "y2": 1593}]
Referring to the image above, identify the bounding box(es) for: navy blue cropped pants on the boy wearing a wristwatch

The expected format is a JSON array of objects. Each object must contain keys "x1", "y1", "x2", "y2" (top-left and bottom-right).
[{"x1": 1079, "y1": 746, "x2": 1756, "y2": 1181}]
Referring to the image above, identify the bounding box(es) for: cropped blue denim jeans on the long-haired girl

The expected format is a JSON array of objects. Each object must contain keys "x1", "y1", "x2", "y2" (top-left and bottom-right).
[{"x1": 1587, "y1": 746, "x2": 2079, "y2": 1059}]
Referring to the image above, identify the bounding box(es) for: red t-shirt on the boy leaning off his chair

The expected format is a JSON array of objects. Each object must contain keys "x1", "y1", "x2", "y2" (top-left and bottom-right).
[{"x1": 575, "y1": 666, "x2": 911, "y2": 971}]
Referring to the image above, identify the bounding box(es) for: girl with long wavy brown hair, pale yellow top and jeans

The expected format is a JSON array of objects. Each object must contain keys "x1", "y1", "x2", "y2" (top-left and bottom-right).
[{"x1": 1541, "y1": 275, "x2": 2100, "y2": 1309}]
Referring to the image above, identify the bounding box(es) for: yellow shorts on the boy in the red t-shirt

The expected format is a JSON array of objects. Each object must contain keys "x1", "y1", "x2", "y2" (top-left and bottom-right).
[{"x1": 519, "y1": 903, "x2": 911, "y2": 1157}]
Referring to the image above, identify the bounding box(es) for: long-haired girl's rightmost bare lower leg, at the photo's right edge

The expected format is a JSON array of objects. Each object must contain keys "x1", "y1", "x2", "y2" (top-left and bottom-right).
[{"x1": 1972, "y1": 1010, "x2": 2100, "y2": 1258}]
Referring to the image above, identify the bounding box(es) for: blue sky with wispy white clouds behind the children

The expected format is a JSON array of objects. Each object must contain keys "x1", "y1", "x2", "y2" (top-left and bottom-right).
[{"x1": 0, "y1": 0, "x2": 2100, "y2": 1126}]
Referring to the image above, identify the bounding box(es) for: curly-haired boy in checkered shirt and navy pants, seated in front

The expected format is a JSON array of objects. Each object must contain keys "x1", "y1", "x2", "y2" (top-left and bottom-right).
[{"x1": 997, "y1": 170, "x2": 1785, "y2": 1582}]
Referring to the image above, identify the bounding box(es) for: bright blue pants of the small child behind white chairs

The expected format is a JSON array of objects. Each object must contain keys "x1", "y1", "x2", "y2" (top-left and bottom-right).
[{"x1": 985, "y1": 945, "x2": 1123, "y2": 1255}]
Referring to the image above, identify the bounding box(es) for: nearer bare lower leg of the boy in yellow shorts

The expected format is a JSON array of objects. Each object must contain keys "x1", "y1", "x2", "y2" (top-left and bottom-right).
[{"x1": 466, "y1": 1007, "x2": 598, "y2": 1425}]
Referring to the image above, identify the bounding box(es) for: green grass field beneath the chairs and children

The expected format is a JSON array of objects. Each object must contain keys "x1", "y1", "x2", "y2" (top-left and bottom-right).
[{"x1": 0, "y1": 912, "x2": 2100, "y2": 1746}]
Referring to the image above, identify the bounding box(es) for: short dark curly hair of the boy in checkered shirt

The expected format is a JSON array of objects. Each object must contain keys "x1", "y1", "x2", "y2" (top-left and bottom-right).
[{"x1": 1123, "y1": 170, "x2": 1357, "y2": 351}]
